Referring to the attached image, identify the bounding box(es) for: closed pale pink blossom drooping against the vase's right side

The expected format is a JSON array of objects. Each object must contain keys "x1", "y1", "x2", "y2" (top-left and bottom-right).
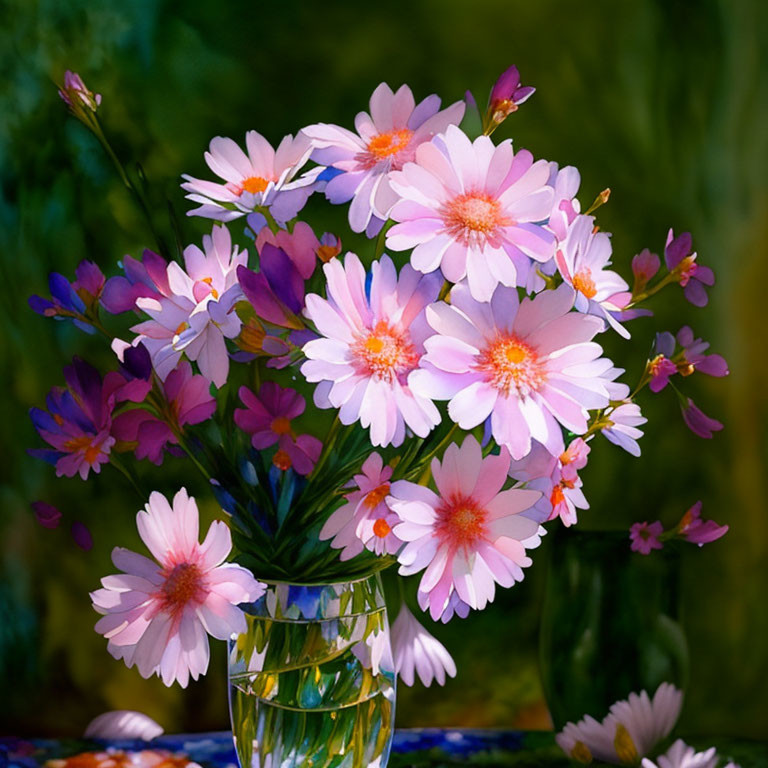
[{"x1": 392, "y1": 603, "x2": 456, "y2": 688}]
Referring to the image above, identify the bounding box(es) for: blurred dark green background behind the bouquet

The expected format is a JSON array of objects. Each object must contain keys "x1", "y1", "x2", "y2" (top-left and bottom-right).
[{"x1": 0, "y1": 0, "x2": 768, "y2": 737}]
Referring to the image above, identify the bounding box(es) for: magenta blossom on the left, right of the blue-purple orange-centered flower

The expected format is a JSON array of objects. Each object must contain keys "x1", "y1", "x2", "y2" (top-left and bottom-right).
[{"x1": 112, "y1": 360, "x2": 216, "y2": 464}]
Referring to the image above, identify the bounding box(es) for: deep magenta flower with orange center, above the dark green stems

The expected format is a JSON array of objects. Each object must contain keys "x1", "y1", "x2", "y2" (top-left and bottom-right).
[{"x1": 235, "y1": 381, "x2": 323, "y2": 475}]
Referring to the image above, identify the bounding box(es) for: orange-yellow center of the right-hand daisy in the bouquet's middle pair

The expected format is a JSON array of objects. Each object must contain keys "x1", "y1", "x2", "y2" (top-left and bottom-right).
[{"x1": 477, "y1": 336, "x2": 545, "y2": 397}]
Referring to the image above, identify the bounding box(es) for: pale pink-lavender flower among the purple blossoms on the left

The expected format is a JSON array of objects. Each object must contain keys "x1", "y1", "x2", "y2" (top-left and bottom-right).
[{"x1": 131, "y1": 224, "x2": 248, "y2": 387}]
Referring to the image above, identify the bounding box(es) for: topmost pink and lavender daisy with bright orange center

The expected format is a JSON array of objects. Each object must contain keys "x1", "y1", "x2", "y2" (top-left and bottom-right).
[{"x1": 303, "y1": 83, "x2": 464, "y2": 236}]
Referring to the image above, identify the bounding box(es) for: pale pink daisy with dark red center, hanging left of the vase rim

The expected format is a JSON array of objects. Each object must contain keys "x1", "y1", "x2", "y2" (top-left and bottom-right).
[{"x1": 91, "y1": 488, "x2": 264, "y2": 687}]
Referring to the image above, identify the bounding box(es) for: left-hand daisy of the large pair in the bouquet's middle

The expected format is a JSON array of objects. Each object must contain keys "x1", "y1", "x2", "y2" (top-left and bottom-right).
[{"x1": 301, "y1": 253, "x2": 441, "y2": 446}]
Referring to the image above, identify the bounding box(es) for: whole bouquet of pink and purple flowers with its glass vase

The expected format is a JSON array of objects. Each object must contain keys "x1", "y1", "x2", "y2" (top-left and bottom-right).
[{"x1": 30, "y1": 67, "x2": 728, "y2": 765}]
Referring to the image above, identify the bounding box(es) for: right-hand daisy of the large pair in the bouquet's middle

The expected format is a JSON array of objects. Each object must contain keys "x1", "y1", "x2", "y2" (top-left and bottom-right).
[{"x1": 408, "y1": 283, "x2": 616, "y2": 459}]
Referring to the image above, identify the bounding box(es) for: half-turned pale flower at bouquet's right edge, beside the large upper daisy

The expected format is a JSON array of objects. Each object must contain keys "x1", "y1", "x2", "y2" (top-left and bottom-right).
[{"x1": 555, "y1": 215, "x2": 631, "y2": 339}]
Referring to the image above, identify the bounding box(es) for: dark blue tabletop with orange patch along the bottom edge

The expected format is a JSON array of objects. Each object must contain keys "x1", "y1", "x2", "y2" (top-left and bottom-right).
[{"x1": 0, "y1": 728, "x2": 768, "y2": 768}]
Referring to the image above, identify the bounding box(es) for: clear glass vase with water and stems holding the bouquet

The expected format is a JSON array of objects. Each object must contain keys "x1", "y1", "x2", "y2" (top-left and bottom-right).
[{"x1": 229, "y1": 576, "x2": 395, "y2": 768}]
